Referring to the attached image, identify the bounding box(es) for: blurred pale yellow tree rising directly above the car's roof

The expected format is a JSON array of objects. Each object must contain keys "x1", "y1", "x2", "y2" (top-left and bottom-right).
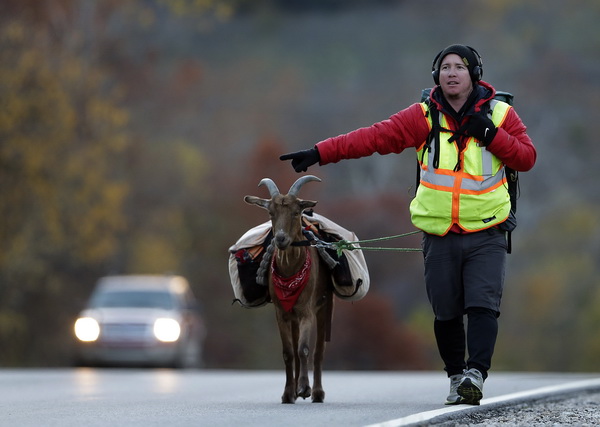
[{"x1": 120, "y1": 139, "x2": 210, "y2": 274}]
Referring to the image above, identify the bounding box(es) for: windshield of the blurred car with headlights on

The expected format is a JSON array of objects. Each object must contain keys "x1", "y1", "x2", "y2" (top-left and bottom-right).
[{"x1": 91, "y1": 291, "x2": 175, "y2": 310}]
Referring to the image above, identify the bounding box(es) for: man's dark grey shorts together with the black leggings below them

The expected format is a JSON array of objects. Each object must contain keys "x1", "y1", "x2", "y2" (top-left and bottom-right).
[{"x1": 423, "y1": 228, "x2": 507, "y2": 379}]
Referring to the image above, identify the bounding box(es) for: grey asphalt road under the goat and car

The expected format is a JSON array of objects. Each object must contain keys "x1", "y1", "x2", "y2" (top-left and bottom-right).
[{"x1": 0, "y1": 368, "x2": 600, "y2": 427}]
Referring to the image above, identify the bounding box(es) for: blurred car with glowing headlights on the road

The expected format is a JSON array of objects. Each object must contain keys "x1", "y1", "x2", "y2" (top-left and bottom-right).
[{"x1": 74, "y1": 275, "x2": 205, "y2": 368}]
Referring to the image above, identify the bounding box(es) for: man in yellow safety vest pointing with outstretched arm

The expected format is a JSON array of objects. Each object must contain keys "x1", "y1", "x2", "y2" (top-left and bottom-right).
[{"x1": 280, "y1": 44, "x2": 536, "y2": 405}]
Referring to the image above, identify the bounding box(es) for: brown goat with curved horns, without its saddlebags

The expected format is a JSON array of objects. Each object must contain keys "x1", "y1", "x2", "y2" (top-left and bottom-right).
[{"x1": 244, "y1": 175, "x2": 333, "y2": 403}]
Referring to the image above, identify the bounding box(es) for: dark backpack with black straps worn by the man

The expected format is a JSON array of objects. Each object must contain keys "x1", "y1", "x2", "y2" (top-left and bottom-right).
[{"x1": 415, "y1": 88, "x2": 519, "y2": 253}]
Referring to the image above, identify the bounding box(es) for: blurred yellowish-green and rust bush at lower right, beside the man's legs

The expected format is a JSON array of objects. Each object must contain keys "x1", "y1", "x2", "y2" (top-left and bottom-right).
[{"x1": 497, "y1": 203, "x2": 600, "y2": 371}]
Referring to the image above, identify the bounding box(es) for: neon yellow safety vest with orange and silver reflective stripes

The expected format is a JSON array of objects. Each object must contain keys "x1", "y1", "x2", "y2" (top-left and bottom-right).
[{"x1": 410, "y1": 100, "x2": 511, "y2": 236}]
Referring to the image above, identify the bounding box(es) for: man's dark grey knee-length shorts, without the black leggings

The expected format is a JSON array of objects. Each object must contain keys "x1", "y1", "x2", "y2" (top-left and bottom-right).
[{"x1": 422, "y1": 228, "x2": 507, "y2": 321}]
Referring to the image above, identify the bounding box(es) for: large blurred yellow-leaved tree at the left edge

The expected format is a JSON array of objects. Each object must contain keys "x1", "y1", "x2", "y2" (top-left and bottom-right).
[{"x1": 0, "y1": 20, "x2": 128, "y2": 364}]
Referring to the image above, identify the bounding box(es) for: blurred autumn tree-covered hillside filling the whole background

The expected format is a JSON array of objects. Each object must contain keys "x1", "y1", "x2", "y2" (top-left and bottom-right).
[{"x1": 0, "y1": 0, "x2": 600, "y2": 369}]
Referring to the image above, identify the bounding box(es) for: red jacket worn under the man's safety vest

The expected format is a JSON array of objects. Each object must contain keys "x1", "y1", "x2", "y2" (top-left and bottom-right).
[{"x1": 316, "y1": 81, "x2": 536, "y2": 172}]
